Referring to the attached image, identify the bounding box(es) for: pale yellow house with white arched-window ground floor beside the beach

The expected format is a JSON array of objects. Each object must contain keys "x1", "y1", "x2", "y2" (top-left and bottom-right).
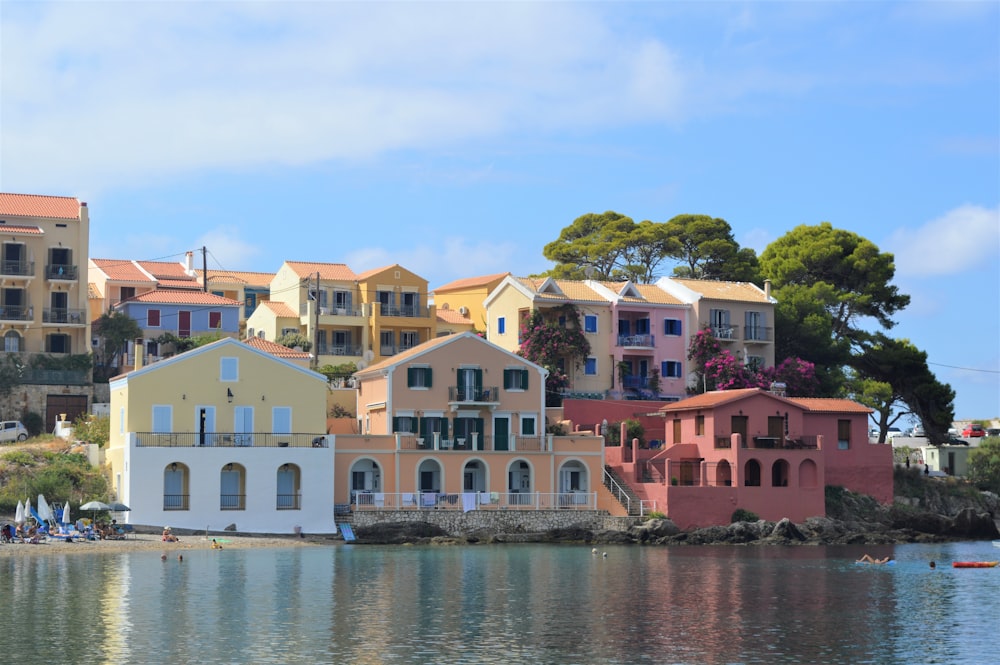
[{"x1": 106, "y1": 338, "x2": 334, "y2": 533}]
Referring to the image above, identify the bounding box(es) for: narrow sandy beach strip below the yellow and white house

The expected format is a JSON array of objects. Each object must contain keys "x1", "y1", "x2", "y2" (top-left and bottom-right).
[{"x1": 0, "y1": 532, "x2": 342, "y2": 557}]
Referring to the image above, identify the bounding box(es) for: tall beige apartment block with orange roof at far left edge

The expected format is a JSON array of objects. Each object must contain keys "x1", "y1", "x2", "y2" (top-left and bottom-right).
[{"x1": 0, "y1": 193, "x2": 90, "y2": 354}]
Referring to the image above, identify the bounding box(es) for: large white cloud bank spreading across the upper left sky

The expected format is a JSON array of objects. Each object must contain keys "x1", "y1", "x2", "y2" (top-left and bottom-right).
[{"x1": 0, "y1": 2, "x2": 683, "y2": 191}]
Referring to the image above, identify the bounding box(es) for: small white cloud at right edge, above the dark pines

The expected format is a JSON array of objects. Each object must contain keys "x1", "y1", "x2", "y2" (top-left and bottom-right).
[{"x1": 885, "y1": 205, "x2": 1000, "y2": 277}]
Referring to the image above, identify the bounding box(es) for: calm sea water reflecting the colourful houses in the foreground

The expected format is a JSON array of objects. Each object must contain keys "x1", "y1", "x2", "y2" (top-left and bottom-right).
[{"x1": 0, "y1": 542, "x2": 1000, "y2": 665}]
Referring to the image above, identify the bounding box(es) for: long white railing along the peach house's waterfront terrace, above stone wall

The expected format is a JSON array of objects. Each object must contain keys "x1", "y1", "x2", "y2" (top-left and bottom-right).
[{"x1": 351, "y1": 490, "x2": 597, "y2": 511}]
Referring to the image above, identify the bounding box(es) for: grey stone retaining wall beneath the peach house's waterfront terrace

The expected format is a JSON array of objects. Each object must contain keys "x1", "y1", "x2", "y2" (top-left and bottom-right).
[{"x1": 351, "y1": 510, "x2": 638, "y2": 536}]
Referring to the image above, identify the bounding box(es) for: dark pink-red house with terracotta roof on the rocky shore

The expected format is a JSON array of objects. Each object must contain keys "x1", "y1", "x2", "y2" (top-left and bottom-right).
[{"x1": 606, "y1": 388, "x2": 892, "y2": 529}]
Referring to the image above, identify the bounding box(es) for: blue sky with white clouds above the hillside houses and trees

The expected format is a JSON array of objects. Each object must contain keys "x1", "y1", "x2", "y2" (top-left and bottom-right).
[{"x1": 0, "y1": 1, "x2": 1000, "y2": 418}]
